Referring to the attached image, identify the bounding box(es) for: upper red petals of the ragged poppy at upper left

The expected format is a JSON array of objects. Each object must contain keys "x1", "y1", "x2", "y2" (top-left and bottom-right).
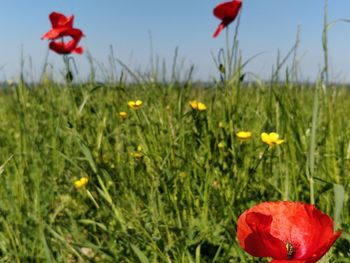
[{"x1": 41, "y1": 12, "x2": 74, "y2": 39}]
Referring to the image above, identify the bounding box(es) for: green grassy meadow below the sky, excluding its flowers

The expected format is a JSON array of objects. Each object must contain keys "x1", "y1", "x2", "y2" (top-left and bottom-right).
[{"x1": 0, "y1": 75, "x2": 350, "y2": 263}]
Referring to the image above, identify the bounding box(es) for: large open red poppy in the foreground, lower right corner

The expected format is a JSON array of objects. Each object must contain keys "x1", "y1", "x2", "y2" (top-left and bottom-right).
[{"x1": 237, "y1": 202, "x2": 341, "y2": 263}]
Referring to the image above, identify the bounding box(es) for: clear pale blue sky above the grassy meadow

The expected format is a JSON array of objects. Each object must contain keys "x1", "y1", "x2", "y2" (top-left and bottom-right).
[{"x1": 0, "y1": 0, "x2": 350, "y2": 81}]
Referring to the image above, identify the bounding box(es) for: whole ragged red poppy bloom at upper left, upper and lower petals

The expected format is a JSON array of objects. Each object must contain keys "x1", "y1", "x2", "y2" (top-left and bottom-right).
[{"x1": 41, "y1": 12, "x2": 84, "y2": 55}]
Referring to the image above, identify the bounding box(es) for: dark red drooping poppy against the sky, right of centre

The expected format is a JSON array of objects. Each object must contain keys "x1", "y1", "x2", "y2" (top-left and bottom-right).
[{"x1": 213, "y1": 0, "x2": 242, "y2": 37}]
